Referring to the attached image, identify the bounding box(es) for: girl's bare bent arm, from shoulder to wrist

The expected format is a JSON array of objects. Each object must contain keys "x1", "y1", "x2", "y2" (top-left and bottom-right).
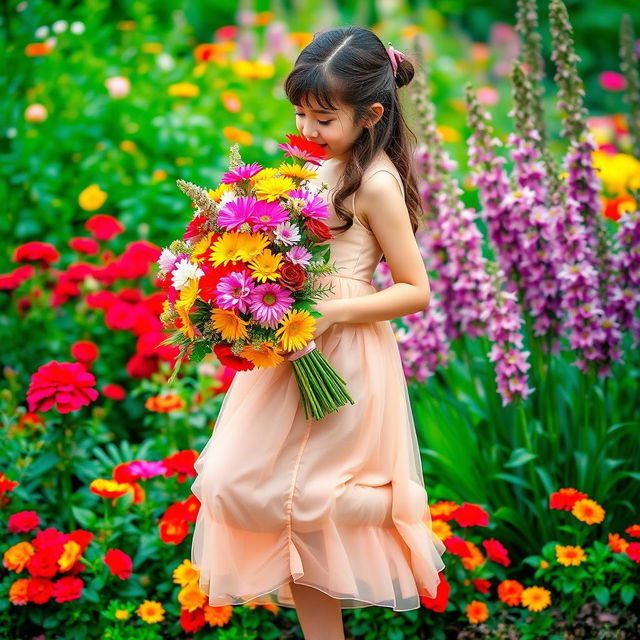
[{"x1": 327, "y1": 171, "x2": 431, "y2": 323}]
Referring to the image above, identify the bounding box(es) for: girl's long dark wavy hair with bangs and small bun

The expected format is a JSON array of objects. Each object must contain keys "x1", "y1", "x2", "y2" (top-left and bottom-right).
[{"x1": 284, "y1": 26, "x2": 422, "y2": 260}]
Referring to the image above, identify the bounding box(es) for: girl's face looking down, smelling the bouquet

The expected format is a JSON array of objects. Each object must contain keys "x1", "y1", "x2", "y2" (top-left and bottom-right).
[{"x1": 294, "y1": 96, "x2": 363, "y2": 161}]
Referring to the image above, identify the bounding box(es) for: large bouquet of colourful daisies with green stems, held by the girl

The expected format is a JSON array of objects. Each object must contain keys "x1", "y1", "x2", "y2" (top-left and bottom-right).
[{"x1": 158, "y1": 134, "x2": 354, "y2": 420}]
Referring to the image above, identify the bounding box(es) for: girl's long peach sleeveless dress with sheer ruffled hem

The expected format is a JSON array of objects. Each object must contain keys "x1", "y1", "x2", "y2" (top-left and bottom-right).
[{"x1": 191, "y1": 159, "x2": 445, "y2": 611}]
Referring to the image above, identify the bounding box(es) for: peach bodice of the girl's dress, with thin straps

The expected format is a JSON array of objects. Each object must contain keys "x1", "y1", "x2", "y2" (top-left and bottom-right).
[{"x1": 309, "y1": 162, "x2": 404, "y2": 282}]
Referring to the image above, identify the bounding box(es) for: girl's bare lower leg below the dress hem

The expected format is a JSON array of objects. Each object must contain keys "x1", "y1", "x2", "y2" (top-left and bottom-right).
[{"x1": 290, "y1": 581, "x2": 344, "y2": 640}]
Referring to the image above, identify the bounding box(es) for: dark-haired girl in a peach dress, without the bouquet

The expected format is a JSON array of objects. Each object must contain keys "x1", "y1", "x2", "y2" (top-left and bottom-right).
[{"x1": 191, "y1": 27, "x2": 445, "y2": 640}]
